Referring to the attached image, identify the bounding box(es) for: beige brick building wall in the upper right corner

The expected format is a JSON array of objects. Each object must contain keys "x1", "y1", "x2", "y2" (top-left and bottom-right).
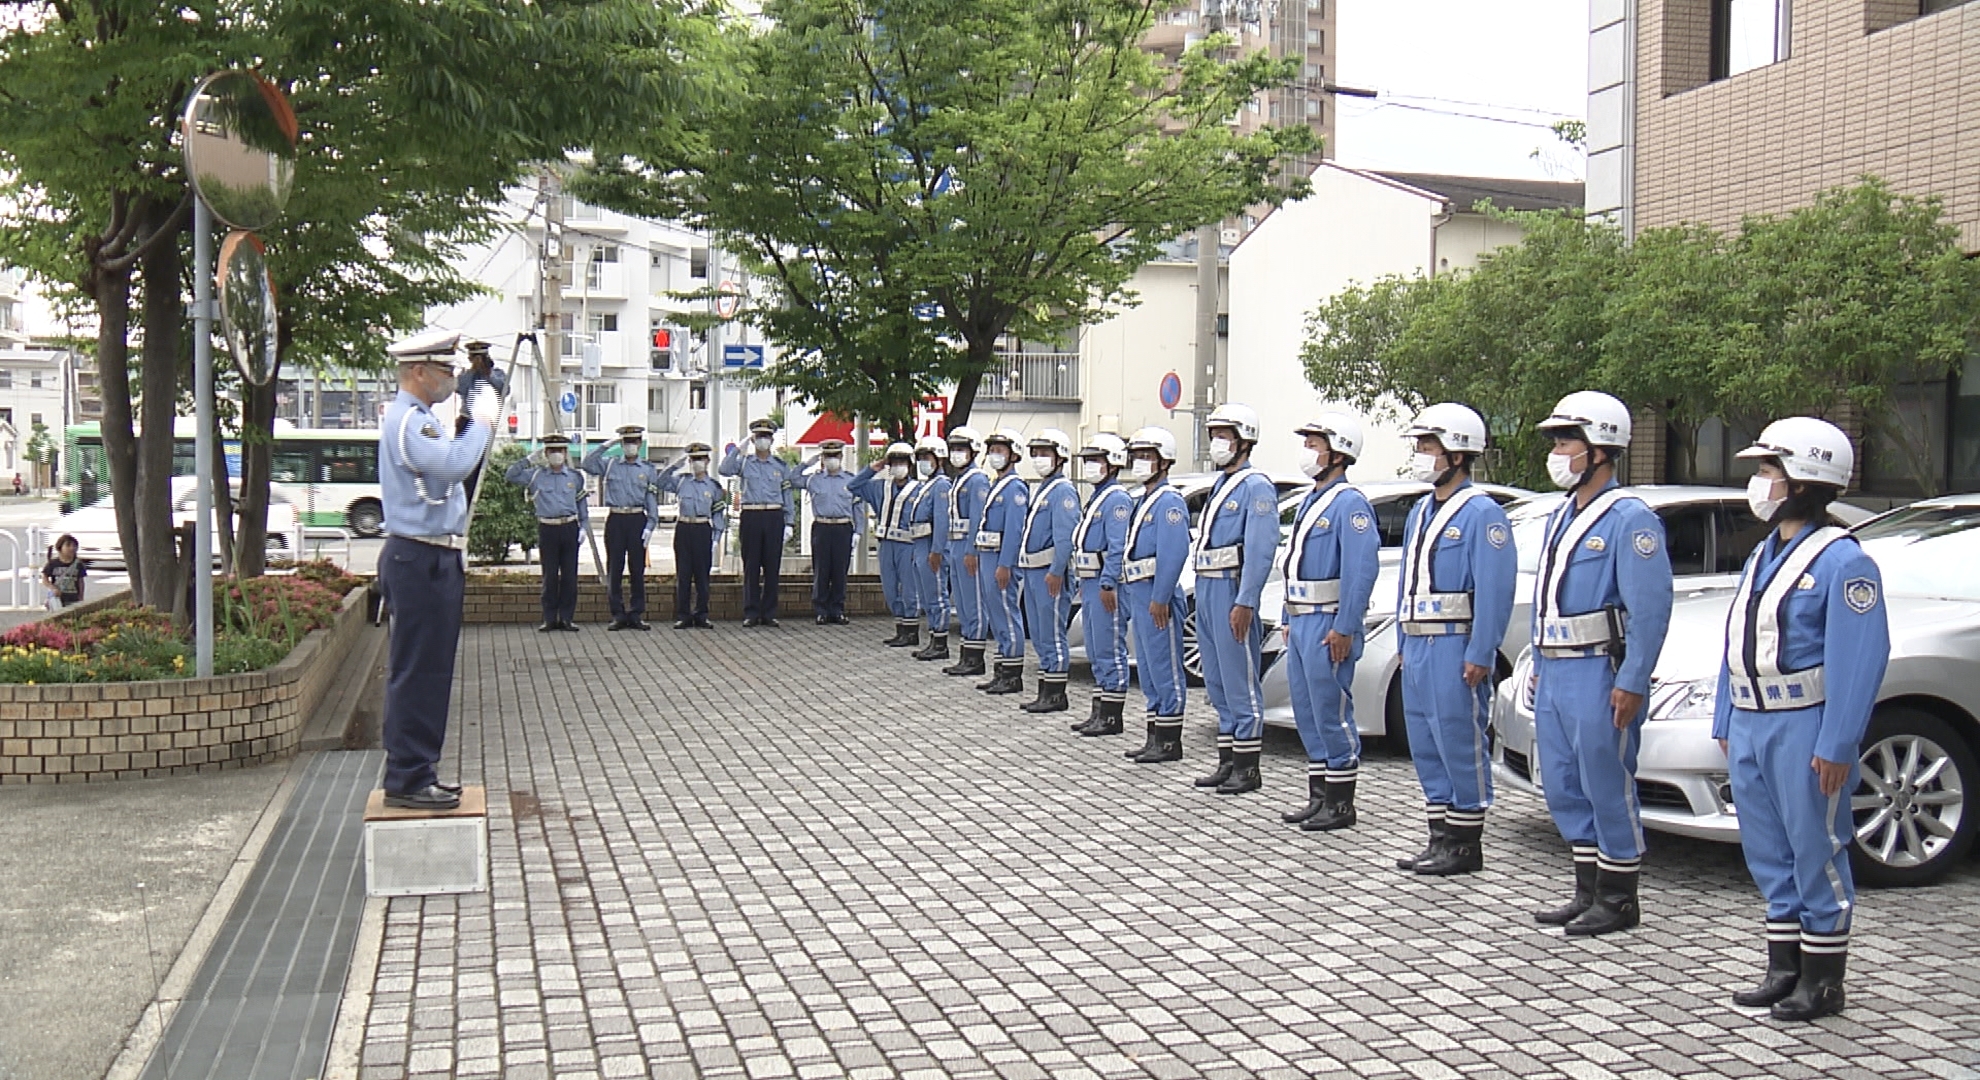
[{"x1": 1635, "y1": 0, "x2": 1980, "y2": 252}]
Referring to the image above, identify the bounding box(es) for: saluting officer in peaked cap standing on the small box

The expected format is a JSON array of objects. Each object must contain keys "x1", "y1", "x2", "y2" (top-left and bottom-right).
[{"x1": 378, "y1": 331, "x2": 501, "y2": 810}]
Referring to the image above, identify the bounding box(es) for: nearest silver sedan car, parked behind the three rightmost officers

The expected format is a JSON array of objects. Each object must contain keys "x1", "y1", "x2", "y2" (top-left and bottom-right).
[{"x1": 1493, "y1": 495, "x2": 1980, "y2": 886}]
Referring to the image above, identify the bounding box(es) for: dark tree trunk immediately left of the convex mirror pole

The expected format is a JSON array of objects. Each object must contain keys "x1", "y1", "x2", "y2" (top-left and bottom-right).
[{"x1": 131, "y1": 208, "x2": 186, "y2": 604}]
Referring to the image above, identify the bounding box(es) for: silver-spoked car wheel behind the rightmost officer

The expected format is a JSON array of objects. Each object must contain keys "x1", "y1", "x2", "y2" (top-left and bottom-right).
[{"x1": 1849, "y1": 707, "x2": 1980, "y2": 886}]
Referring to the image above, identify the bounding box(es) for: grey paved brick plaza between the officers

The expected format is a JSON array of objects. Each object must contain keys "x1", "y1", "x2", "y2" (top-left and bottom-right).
[{"x1": 364, "y1": 618, "x2": 1980, "y2": 1080}]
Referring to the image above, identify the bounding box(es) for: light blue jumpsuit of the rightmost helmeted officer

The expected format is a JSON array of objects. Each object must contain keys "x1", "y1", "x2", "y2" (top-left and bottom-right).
[{"x1": 1713, "y1": 529, "x2": 1891, "y2": 967}]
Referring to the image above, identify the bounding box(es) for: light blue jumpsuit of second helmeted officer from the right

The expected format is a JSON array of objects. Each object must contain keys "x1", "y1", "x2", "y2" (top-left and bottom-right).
[{"x1": 1533, "y1": 482, "x2": 1673, "y2": 874}]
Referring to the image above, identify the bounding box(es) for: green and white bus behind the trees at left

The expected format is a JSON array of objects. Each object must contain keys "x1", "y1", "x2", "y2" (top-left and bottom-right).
[{"x1": 61, "y1": 422, "x2": 384, "y2": 537}]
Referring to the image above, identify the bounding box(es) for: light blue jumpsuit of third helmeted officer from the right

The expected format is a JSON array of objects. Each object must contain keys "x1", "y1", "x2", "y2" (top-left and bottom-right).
[{"x1": 1396, "y1": 480, "x2": 1519, "y2": 828}]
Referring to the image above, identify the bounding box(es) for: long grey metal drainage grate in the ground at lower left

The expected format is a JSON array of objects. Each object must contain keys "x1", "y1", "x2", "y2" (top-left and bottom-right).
[{"x1": 143, "y1": 751, "x2": 384, "y2": 1080}]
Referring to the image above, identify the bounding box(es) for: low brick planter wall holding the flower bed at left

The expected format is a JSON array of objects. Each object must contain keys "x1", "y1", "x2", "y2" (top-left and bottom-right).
[{"x1": 0, "y1": 589, "x2": 364, "y2": 785}]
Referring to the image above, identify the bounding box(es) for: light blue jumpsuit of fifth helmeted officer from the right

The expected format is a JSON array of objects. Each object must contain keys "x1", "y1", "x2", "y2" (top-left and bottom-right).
[{"x1": 1194, "y1": 468, "x2": 1279, "y2": 755}]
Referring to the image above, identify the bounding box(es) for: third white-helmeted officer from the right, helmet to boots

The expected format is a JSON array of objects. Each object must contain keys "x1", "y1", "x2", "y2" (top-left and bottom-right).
[{"x1": 1396, "y1": 402, "x2": 1519, "y2": 876}]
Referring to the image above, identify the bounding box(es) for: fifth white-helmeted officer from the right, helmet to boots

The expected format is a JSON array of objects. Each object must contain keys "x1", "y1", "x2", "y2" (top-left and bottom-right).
[{"x1": 1192, "y1": 404, "x2": 1279, "y2": 795}]
